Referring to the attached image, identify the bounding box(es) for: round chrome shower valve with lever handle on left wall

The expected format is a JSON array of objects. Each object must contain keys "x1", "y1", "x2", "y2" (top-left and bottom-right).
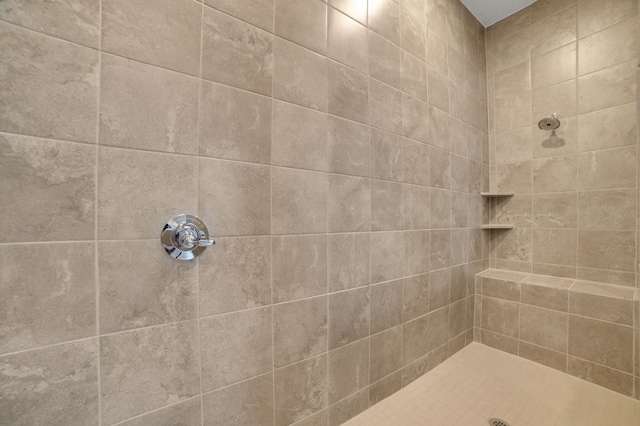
[{"x1": 160, "y1": 214, "x2": 215, "y2": 260}]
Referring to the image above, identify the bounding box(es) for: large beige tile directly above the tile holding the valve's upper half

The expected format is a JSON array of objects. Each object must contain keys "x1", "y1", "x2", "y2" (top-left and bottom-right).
[{"x1": 99, "y1": 55, "x2": 199, "y2": 155}]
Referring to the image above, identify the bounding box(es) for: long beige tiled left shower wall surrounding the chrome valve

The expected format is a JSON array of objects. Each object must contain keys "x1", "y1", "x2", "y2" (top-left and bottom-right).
[{"x1": 0, "y1": 0, "x2": 489, "y2": 426}]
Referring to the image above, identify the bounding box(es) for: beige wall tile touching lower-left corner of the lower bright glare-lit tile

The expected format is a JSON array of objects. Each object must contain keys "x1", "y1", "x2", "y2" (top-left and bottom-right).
[{"x1": 273, "y1": 37, "x2": 328, "y2": 111}]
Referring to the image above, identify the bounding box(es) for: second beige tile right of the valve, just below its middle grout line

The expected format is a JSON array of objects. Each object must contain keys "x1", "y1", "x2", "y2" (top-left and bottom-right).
[{"x1": 271, "y1": 235, "x2": 328, "y2": 302}]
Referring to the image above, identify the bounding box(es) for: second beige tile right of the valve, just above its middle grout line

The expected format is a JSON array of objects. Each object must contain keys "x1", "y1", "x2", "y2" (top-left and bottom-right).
[{"x1": 267, "y1": 168, "x2": 328, "y2": 234}]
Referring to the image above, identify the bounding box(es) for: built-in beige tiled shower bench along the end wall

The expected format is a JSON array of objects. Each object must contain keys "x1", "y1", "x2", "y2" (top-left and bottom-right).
[{"x1": 475, "y1": 269, "x2": 638, "y2": 396}]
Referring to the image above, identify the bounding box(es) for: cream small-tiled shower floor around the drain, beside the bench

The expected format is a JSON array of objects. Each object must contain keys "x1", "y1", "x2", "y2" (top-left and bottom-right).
[{"x1": 345, "y1": 343, "x2": 640, "y2": 426}]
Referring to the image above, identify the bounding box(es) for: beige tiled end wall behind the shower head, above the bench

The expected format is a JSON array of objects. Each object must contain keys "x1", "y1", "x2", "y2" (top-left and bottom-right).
[{"x1": 486, "y1": 0, "x2": 638, "y2": 286}]
